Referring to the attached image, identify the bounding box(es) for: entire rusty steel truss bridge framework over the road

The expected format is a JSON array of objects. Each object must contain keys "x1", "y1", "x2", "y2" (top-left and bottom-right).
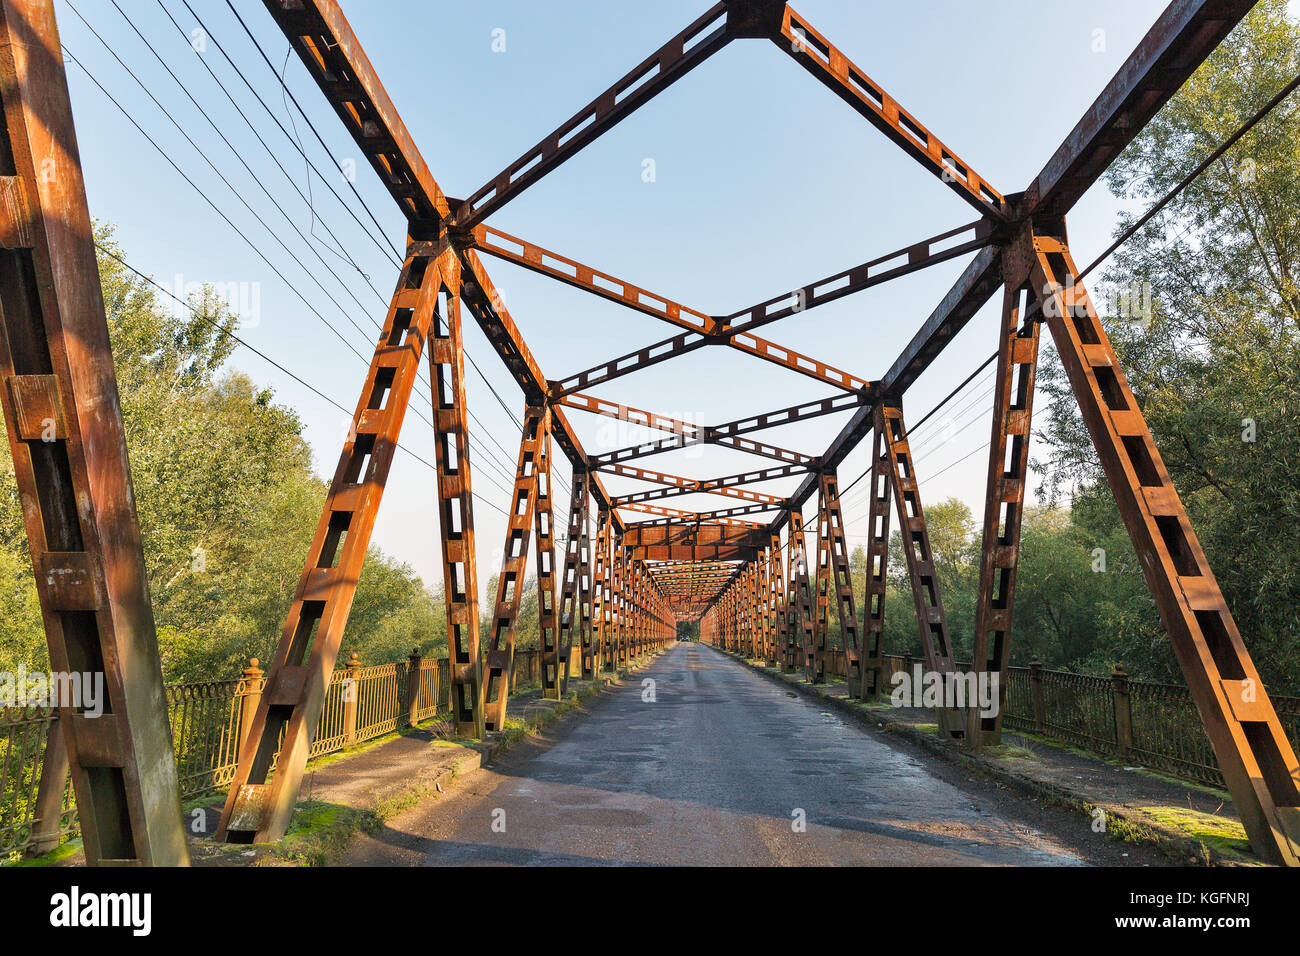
[{"x1": 0, "y1": 0, "x2": 1300, "y2": 865}]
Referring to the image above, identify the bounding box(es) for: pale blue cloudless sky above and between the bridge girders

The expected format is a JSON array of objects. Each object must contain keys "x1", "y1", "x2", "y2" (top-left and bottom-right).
[{"x1": 56, "y1": 0, "x2": 1196, "y2": 583}]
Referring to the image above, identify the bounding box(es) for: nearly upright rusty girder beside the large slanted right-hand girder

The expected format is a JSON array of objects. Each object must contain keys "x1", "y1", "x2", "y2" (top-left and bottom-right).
[{"x1": 967, "y1": 261, "x2": 1041, "y2": 748}]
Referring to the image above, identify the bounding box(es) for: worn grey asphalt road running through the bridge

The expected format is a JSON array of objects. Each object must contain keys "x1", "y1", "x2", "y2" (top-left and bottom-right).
[{"x1": 348, "y1": 643, "x2": 1159, "y2": 866}]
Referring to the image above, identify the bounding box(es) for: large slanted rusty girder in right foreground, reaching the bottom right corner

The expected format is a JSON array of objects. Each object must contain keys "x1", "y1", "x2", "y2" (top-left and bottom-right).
[{"x1": 1031, "y1": 234, "x2": 1300, "y2": 866}]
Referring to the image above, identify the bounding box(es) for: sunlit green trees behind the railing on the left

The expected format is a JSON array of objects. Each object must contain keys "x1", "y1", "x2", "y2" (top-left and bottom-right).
[{"x1": 0, "y1": 228, "x2": 446, "y2": 682}]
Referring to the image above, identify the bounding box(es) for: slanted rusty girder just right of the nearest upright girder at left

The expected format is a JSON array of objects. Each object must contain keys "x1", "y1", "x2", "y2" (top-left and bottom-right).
[{"x1": 484, "y1": 405, "x2": 550, "y2": 730}]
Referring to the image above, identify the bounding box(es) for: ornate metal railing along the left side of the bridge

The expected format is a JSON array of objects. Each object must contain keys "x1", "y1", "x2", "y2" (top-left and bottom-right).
[{"x1": 0, "y1": 648, "x2": 540, "y2": 858}]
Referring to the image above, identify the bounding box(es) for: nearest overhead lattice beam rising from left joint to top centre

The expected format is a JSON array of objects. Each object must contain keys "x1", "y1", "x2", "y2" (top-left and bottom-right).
[{"x1": 452, "y1": 0, "x2": 736, "y2": 229}]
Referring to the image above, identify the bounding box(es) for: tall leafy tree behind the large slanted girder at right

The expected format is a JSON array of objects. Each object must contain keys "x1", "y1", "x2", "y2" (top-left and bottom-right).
[{"x1": 1036, "y1": 0, "x2": 1300, "y2": 692}]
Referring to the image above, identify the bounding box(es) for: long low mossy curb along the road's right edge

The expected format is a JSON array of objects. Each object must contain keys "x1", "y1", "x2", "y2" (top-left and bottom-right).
[{"x1": 722, "y1": 645, "x2": 1264, "y2": 866}]
